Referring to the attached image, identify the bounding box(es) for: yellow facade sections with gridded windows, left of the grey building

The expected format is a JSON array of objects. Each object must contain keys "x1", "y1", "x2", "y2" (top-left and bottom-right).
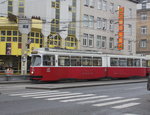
[{"x1": 0, "y1": 17, "x2": 78, "y2": 73}]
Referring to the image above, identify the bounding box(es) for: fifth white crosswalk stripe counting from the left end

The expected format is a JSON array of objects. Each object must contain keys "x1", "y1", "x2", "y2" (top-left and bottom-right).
[{"x1": 60, "y1": 95, "x2": 108, "y2": 102}]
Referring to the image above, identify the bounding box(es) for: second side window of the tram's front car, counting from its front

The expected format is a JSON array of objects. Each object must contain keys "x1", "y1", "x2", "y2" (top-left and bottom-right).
[{"x1": 58, "y1": 56, "x2": 70, "y2": 66}]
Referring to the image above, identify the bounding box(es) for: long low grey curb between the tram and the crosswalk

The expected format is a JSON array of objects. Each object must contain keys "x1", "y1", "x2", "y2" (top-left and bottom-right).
[{"x1": 25, "y1": 79, "x2": 147, "y2": 90}]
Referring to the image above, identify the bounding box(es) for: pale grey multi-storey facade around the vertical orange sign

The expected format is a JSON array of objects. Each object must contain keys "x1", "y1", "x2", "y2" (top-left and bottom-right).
[{"x1": 80, "y1": 0, "x2": 136, "y2": 55}]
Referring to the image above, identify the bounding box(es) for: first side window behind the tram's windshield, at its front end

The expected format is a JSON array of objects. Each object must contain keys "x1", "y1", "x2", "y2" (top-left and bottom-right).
[{"x1": 43, "y1": 55, "x2": 55, "y2": 66}]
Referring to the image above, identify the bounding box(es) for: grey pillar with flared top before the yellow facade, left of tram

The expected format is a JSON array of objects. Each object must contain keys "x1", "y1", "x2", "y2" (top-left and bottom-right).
[{"x1": 18, "y1": 17, "x2": 31, "y2": 75}]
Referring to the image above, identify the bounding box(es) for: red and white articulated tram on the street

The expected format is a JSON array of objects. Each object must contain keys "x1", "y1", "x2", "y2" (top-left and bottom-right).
[{"x1": 30, "y1": 48, "x2": 147, "y2": 81}]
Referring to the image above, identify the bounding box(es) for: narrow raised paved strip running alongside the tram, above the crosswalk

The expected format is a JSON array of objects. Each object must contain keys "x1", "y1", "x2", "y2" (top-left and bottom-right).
[{"x1": 26, "y1": 78, "x2": 147, "y2": 90}]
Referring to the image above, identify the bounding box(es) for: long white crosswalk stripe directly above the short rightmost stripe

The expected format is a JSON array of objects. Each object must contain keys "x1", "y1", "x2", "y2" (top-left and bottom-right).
[{"x1": 93, "y1": 98, "x2": 139, "y2": 107}]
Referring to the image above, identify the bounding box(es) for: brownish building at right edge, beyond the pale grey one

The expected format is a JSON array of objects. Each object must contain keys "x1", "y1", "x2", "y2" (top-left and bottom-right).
[{"x1": 136, "y1": 0, "x2": 150, "y2": 55}]
